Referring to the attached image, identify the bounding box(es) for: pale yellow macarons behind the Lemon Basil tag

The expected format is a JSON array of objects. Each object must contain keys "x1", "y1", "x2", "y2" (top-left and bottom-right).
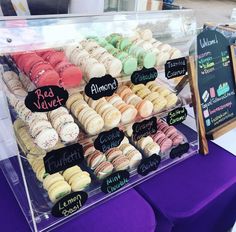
[{"x1": 28, "y1": 154, "x2": 91, "y2": 203}]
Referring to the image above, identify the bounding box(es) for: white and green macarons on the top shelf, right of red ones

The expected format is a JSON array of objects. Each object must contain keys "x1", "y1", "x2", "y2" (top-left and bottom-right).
[{"x1": 64, "y1": 31, "x2": 181, "y2": 80}]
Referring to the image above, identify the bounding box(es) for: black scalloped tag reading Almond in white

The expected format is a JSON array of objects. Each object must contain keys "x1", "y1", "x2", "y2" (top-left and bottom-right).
[{"x1": 85, "y1": 75, "x2": 118, "y2": 100}]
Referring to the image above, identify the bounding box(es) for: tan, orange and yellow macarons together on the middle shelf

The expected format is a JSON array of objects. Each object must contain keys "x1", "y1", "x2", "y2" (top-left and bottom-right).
[{"x1": 66, "y1": 82, "x2": 178, "y2": 135}]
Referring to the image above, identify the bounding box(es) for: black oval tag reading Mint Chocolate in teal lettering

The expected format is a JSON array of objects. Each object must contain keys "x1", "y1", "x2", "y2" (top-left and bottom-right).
[{"x1": 101, "y1": 170, "x2": 130, "y2": 193}]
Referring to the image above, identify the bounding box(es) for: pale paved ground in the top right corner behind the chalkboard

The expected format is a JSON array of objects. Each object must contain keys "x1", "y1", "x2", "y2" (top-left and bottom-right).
[{"x1": 174, "y1": 0, "x2": 236, "y2": 26}]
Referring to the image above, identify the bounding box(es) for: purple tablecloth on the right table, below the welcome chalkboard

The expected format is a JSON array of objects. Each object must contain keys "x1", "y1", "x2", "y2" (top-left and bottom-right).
[{"x1": 136, "y1": 142, "x2": 236, "y2": 232}]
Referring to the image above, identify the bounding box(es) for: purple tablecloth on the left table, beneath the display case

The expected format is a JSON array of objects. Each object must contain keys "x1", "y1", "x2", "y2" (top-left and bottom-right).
[{"x1": 0, "y1": 169, "x2": 156, "y2": 232}]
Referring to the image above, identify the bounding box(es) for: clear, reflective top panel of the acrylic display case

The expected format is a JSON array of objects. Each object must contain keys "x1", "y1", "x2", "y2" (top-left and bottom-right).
[{"x1": 0, "y1": 9, "x2": 196, "y2": 53}]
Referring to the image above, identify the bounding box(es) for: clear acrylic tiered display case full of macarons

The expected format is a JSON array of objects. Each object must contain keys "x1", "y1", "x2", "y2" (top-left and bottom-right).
[{"x1": 0, "y1": 5, "x2": 198, "y2": 231}]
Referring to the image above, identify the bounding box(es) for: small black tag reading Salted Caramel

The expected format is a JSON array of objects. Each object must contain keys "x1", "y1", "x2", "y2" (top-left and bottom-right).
[{"x1": 166, "y1": 107, "x2": 188, "y2": 126}]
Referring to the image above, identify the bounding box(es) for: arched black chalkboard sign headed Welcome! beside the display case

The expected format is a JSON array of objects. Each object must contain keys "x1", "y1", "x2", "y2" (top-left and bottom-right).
[{"x1": 197, "y1": 30, "x2": 236, "y2": 134}]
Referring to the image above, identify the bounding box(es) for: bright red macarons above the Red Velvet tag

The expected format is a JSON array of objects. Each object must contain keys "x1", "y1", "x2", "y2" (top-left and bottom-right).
[{"x1": 12, "y1": 49, "x2": 82, "y2": 88}]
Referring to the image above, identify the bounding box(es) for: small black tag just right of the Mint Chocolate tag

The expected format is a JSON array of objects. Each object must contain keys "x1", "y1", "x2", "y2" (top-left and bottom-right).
[{"x1": 137, "y1": 154, "x2": 161, "y2": 176}]
